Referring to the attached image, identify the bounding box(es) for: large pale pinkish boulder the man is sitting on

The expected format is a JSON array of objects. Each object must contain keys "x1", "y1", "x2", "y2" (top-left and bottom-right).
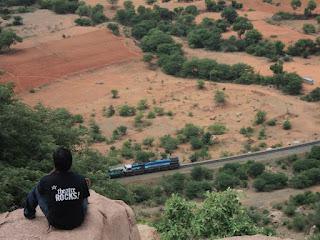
[{"x1": 0, "y1": 191, "x2": 141, "y2": 240}]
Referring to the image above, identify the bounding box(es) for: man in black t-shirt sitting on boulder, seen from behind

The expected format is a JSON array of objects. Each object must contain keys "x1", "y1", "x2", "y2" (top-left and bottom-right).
[{"x1": 24, "y1": 147, "x2": 90, "y2": 229}]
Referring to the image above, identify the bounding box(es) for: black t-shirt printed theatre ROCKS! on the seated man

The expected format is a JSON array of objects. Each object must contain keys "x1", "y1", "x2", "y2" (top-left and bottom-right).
[{"x1": 38, "y1": 171, "x2": 90, "y2": 229}]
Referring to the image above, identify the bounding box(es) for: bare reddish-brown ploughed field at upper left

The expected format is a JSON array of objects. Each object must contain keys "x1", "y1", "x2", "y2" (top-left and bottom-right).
[{"x1": 0, "y1": 30, "x2": 140, "y2": 92}]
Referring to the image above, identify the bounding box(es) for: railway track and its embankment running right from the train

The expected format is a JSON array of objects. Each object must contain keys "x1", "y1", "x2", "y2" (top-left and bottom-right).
[{"x1": 118, "y1": 140, "x2": 320, "y2": 184}]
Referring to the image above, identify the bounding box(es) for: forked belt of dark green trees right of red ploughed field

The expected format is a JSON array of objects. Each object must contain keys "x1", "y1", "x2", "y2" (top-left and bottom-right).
[{"x1": 116, "y1": 2, "x2": 302, "y2": 94}]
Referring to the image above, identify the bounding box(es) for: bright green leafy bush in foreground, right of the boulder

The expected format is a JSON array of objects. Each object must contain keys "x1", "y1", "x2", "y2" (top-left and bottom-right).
[{"x1": 156, "y1": 190, "x2": 262, "y2": 240}]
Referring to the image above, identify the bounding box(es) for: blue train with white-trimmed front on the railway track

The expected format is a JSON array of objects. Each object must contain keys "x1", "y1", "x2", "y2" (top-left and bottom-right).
[{"x1": 108, "y1": 157, "x2": 180, "y2": 178}]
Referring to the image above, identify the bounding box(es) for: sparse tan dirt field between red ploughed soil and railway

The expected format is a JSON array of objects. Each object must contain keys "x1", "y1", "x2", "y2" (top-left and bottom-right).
[{"x1": 22, "y1": 59, "x2": 320, "y2": 160}]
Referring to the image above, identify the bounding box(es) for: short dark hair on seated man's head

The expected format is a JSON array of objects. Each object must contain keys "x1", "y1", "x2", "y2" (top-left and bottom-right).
[{"x1": 53, "y1": 147, "x2": 72, "y2": 172}]
